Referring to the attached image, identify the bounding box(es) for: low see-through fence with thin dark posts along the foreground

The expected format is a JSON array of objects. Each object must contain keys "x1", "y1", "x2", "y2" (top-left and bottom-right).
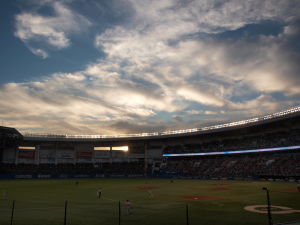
[{"x1": 0, "y1": 197, "x2": 300, "y2": 225}]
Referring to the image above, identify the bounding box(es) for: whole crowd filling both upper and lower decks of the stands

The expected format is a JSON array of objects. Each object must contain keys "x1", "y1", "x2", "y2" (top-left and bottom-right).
[{"x1": 0, "y1": 125, "x2": 300, "y2": 178}]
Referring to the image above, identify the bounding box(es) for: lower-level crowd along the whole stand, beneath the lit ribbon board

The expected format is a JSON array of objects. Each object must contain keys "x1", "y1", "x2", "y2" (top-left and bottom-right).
[{"x1": 0, "y1": 150, "x2": 300, "y2": 178}]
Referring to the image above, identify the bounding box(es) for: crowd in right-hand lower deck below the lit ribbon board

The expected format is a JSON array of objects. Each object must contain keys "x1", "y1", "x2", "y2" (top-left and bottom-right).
[{"x1": 162, "y1": 153, "x2": 300, "y2": 178}]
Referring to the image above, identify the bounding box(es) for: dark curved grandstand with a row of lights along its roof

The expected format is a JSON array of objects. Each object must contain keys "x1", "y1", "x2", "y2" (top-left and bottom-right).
[{"x1": 0, "y1": 107, "x2": 300, "y2": 180}]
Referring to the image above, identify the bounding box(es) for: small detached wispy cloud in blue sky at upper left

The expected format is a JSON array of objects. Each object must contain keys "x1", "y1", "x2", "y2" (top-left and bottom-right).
[{"x1": 15, "y1": 1, "x2": 90, "y2": 58}]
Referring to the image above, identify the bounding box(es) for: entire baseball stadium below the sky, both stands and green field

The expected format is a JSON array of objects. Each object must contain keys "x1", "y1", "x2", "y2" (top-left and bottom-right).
[{"x1": 0, "y1": 107, "x2": 300, "y2": 225}]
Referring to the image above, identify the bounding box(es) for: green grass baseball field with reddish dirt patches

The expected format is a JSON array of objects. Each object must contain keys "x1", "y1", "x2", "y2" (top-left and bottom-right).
[{"x1": 0, "y1": 179, "x2": 300, "y2": 225}]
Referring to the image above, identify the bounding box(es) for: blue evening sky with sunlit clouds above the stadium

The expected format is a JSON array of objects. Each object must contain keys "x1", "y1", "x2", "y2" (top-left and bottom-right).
[{"x1": 0, "y1": 0, "x2": 300, "y2": 134}]
